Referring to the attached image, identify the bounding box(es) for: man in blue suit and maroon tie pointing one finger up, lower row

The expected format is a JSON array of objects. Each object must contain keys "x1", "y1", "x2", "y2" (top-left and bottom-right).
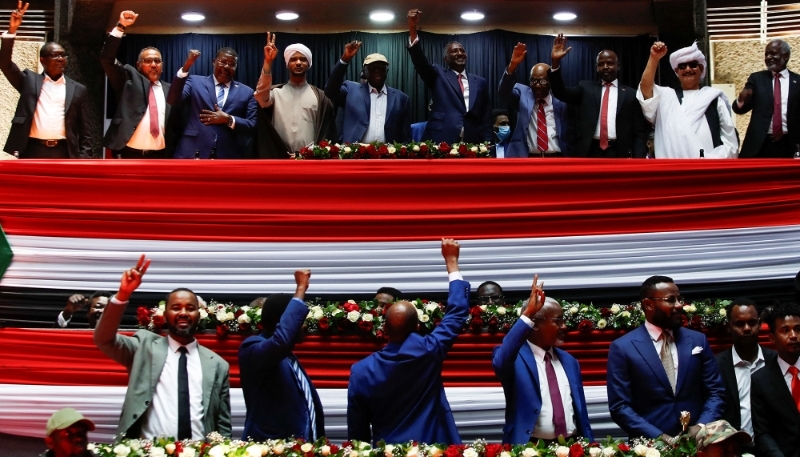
[{"x1": 492, "y1": 275, "x2": 594, "y2": 444}]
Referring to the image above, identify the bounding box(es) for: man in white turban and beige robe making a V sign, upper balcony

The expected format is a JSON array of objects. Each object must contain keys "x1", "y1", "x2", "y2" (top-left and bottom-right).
[{"x1": 255, "y1": 32, "x2": 336, "y2": 159}]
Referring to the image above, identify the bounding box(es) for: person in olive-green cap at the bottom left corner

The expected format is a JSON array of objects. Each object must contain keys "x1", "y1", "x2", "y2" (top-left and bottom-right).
[{"x1": 41, "y1": 408, "x2": 95, "y2": 457}]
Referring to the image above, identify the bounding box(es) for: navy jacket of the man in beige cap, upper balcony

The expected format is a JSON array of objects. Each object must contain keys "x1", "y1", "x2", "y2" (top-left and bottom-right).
[{"x1": 325, "y1": 61, "x2": 411, "y2": 143}]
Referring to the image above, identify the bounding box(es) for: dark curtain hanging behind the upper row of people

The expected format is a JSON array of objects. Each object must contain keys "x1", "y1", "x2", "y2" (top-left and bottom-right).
[{"x1": 120, "y1": 30, "x2": 653, "y2": 126}]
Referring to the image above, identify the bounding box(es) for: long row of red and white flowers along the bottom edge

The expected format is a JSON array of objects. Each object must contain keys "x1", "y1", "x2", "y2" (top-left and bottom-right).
[{"x1": 89, "y1": 432, "x2": 697, "y2": 457}]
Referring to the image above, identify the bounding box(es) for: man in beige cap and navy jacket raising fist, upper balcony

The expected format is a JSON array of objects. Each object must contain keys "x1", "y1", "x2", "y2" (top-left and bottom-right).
[{"x1": 325, "y1": 41, "x2": 411, "y2": 143}]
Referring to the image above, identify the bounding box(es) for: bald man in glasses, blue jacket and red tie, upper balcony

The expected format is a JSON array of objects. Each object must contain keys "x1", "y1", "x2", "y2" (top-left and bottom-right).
[{"x1": 497, "y1": 43, "x2": 570, "y2": 157}]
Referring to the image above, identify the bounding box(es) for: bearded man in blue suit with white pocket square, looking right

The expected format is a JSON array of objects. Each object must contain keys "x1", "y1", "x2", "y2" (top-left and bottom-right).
[{"x1": 606, "y1": 276, "x2": 725, "y2": 442}]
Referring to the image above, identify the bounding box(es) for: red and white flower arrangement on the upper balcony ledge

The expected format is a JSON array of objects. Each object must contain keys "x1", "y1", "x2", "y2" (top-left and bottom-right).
[{"x1": 295, "y1": 140, "x2": 489, "y2": 160}]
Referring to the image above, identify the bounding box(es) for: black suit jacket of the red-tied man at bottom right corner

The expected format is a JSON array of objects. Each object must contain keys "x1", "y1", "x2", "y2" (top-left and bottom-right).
[{"x1": 750, "y1": 357, "x2": 800, "y2": 457}]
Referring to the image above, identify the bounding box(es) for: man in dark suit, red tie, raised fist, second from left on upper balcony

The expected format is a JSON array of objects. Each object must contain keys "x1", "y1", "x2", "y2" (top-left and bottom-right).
[{"x1": 100, "y1": 11, "x2": 171, "y2": 159}]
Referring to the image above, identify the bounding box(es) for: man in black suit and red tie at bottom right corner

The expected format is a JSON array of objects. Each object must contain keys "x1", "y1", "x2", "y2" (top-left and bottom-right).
[{"x1": 751, "y1": 303, "x2": 800, "y2": 457}]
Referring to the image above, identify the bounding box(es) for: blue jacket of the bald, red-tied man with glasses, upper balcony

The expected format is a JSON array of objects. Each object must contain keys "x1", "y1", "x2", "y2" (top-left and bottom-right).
[{"x1": 497, "y1": 72, "x2": 571, "y2": 157}]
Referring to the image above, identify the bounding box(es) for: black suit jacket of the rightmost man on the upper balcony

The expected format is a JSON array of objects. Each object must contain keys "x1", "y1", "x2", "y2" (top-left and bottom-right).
[{"x1": 731, "y1": 70, "x2": 800, "y2": 157}]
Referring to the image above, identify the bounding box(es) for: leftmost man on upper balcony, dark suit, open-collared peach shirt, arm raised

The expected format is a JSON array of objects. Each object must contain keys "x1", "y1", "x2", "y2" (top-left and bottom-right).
[{"x1": 0, "y1": 0, "x2": 92, "y2": 159}]
